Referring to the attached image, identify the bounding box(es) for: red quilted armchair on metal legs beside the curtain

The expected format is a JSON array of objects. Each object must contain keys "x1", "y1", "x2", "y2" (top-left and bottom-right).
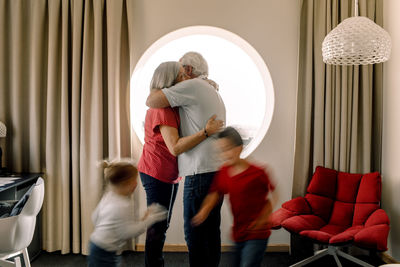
[{"x1": 271, "y1": 167, "x2": 390, "y2": 266}]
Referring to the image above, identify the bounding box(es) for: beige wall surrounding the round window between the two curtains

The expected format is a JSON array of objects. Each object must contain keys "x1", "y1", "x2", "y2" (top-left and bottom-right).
[{"x1": 133, "y1": 0, "x2": 300, "y2": 247}]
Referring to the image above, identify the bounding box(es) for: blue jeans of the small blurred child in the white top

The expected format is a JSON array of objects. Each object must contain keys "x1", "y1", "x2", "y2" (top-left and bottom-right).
[{"x1": 87, "y1": 242, "x2": 121, "y2": 267}]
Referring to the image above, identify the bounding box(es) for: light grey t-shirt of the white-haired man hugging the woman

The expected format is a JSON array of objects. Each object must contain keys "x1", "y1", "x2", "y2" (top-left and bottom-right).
[{"x1": 163, "y1": 78, "x2": 226, "y2": 177}]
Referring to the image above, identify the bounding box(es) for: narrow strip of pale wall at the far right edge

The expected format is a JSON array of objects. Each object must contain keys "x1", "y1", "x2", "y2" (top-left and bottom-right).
[{"x1": 382, "y1": 0, "x2": 400, "y2": 260}]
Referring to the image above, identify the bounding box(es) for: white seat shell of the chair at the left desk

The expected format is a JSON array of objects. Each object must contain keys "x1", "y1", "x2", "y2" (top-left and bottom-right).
[{"x1": 0, "y1": 178, "x2": 44, "y2": 254}]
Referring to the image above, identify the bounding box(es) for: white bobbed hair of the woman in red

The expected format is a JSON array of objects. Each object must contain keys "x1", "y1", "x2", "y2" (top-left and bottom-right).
[{"x1": 150, "y1": 61, "x2": 181, "y2": 89}]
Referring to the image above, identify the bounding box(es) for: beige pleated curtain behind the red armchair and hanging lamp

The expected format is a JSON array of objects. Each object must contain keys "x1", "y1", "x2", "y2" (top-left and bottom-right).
[{"x1": 293, "y1": 0, "x2": 383, "y2": 197}]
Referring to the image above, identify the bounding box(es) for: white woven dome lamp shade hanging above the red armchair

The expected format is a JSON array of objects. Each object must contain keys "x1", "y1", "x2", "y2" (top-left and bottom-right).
[{"x1": 322, "y1": 16, "x2": 391, "y2": 65}]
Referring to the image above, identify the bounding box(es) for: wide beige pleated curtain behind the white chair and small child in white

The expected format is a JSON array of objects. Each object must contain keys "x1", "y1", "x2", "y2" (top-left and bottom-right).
[{"x1": 0, "y1": 0, "x2": 133, "y2": 254}]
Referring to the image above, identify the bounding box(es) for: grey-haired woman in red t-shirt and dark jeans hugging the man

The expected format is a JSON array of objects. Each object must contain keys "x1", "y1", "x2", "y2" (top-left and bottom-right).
[{"x1": 138, "y1": 61, "x2": 223, "y2": 267}]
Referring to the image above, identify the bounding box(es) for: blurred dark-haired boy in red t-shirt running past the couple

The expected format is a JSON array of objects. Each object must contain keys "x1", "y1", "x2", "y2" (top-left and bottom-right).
[{"x1": 192, "y1": 127, "x2": 275, "y2": 267}]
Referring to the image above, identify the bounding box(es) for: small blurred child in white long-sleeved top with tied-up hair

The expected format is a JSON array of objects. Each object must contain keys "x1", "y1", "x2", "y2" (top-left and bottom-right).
[{"x1": 88, "y1": 161, "x2": 167, "y2": 267}]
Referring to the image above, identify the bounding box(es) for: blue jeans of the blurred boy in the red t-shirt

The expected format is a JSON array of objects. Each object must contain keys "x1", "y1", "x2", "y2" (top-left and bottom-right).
[{"x1": 233, "y1": 238, "x2": 268, "y2": 267}]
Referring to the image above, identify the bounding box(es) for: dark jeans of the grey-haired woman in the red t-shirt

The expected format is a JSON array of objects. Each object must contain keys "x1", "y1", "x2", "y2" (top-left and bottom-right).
[{"x1": 140, "y1": 173, "x2": 178, "y2": 267}]
